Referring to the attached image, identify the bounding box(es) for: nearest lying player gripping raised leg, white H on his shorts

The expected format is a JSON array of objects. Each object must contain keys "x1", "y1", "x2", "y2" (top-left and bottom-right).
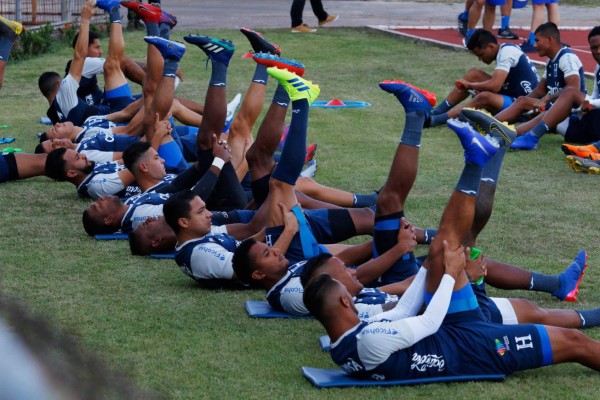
[{"x1": 304, "y1": 131, "x2": 600, "y2": 380}]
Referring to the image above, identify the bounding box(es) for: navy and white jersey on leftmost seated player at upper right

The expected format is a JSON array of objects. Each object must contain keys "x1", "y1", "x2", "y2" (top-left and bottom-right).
[{"x1": 496, "y1": 43, "x2": 540, "y2": 98}]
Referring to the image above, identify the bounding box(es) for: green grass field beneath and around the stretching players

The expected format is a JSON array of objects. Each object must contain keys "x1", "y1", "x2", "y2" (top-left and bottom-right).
[{"x1": 0, "y1": 28, "x2": 600, "y2": 399}]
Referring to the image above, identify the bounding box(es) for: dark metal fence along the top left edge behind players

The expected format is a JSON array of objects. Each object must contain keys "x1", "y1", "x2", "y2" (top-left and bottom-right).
[{"x1": 0, "y1": 0, "x2": 106, "y2": 26}]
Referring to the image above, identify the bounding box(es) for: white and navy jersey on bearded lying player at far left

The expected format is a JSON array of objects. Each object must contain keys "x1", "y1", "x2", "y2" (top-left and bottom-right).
[{"x1": 77, "y1": 162, "x2": 141, "y2": 200}]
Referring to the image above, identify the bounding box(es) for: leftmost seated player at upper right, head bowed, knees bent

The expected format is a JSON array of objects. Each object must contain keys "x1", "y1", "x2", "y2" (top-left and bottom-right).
[{"x1": 425, "y1": 29, "x2": 540, "y2": 126}]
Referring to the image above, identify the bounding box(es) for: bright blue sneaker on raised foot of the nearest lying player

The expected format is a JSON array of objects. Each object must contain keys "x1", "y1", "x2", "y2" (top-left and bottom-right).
[{"x1": 446, "y1": 118, "x2": 500, "y2": 167}]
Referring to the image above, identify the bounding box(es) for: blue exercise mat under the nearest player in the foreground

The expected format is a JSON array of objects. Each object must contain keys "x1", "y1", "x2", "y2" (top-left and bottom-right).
[{"x1": 302, "y1": 367, "x2": 505, "y2": 388}]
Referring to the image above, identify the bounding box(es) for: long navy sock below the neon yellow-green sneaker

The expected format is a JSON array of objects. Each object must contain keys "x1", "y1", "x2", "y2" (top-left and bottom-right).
[{"x1": 272, "y1": 99, "x2": 309, "y2": 185}]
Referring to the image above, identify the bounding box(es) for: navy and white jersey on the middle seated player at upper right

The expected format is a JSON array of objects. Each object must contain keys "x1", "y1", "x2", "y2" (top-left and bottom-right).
[{"x1": 544, "y1": 47, "x2": 586, "y2": 94}]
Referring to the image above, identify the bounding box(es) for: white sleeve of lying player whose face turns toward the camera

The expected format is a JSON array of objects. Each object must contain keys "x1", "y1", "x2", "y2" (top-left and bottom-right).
[{"x1": 190, "y1": 243, "x2": 233, "y2": 279}]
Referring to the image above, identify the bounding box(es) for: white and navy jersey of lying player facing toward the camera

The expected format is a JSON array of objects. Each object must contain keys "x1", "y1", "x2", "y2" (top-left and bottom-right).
[{"x1": 175, "y1": 230, "x2": 239, "y2": 282}]
